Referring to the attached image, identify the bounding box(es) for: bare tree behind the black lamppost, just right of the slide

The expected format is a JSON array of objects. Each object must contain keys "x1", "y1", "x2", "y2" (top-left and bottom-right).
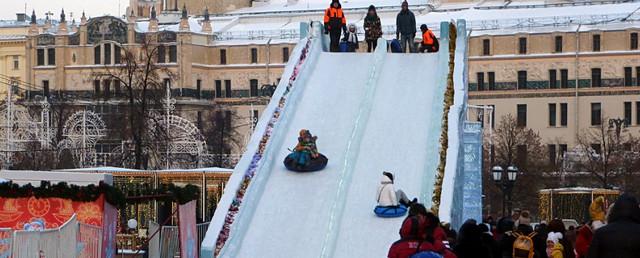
[{"x1": 483, "y1": 114, "x2": 549, "y2": 217}]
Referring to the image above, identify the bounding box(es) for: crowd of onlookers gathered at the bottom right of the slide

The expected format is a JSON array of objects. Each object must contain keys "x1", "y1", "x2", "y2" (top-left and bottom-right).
[{"x1": 388, "y1": 194, "x2": 640, "y2": 258}]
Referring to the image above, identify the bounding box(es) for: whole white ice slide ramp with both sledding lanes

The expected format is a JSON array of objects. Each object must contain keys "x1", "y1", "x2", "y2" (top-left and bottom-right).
[{"x1": 202, "y1": 23, "x2": 470, "y2": 257}]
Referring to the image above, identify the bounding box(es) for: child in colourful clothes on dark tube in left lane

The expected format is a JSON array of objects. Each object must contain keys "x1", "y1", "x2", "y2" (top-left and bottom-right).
[{"x1": 284, "y1": 129, "x2": 327, "y2": 172}]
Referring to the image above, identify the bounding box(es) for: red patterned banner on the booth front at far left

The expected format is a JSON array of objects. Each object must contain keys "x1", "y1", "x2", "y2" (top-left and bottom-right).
[{"x1": 0, "y1": 195, "x2": 105, "y2": 230}]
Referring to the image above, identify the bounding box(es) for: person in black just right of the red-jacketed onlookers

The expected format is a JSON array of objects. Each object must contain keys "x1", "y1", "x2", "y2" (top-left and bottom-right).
[{"x1": 453, "y1": 220, "x2": 492, "y2": 258}]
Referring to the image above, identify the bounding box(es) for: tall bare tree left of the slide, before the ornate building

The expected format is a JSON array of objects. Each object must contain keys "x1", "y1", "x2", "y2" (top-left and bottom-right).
[{"x1": 93, "y1": 39, "x2": 175, "y2": 169}]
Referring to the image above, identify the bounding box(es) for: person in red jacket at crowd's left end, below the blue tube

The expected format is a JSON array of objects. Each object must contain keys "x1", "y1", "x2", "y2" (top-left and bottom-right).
[{"x1": 387, "y1": 215, "x2": 445, "y2": 258}]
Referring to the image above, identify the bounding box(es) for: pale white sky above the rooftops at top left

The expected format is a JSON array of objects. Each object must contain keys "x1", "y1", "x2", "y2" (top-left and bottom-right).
[{"x1": 0, "y1": 0, "x2": 122, "y2": 22}]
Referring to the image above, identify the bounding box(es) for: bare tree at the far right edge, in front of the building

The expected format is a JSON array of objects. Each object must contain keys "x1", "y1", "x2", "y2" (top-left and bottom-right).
[{"x1": 575, "y1": 118, "x2": 640, "y2": 188}]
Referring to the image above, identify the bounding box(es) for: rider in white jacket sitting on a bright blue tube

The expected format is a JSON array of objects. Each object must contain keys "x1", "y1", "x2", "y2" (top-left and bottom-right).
[{"x1": 373, "y1": 171, "x2": 418, "y2": 218}]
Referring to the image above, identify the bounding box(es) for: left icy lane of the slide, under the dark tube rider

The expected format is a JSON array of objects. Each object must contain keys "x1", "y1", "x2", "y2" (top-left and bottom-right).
[{"x1": 221, "y1": 53, "x2": 373, "y2": 257}]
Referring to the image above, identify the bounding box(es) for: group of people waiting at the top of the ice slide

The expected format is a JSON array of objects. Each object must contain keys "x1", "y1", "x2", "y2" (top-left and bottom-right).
[{"x1": 324, "y1": 0, "x2": 439, "y2": 53}]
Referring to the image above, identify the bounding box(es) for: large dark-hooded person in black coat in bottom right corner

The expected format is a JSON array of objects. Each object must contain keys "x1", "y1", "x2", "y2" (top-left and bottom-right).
[{"x1": 587, "y1": 194, "x2": 640, "y2": 258}]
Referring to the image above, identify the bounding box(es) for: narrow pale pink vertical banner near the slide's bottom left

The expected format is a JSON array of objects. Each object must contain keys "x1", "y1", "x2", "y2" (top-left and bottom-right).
[{"x1": 178, "y1": 200, "x2": 198, "y2": 258}]
